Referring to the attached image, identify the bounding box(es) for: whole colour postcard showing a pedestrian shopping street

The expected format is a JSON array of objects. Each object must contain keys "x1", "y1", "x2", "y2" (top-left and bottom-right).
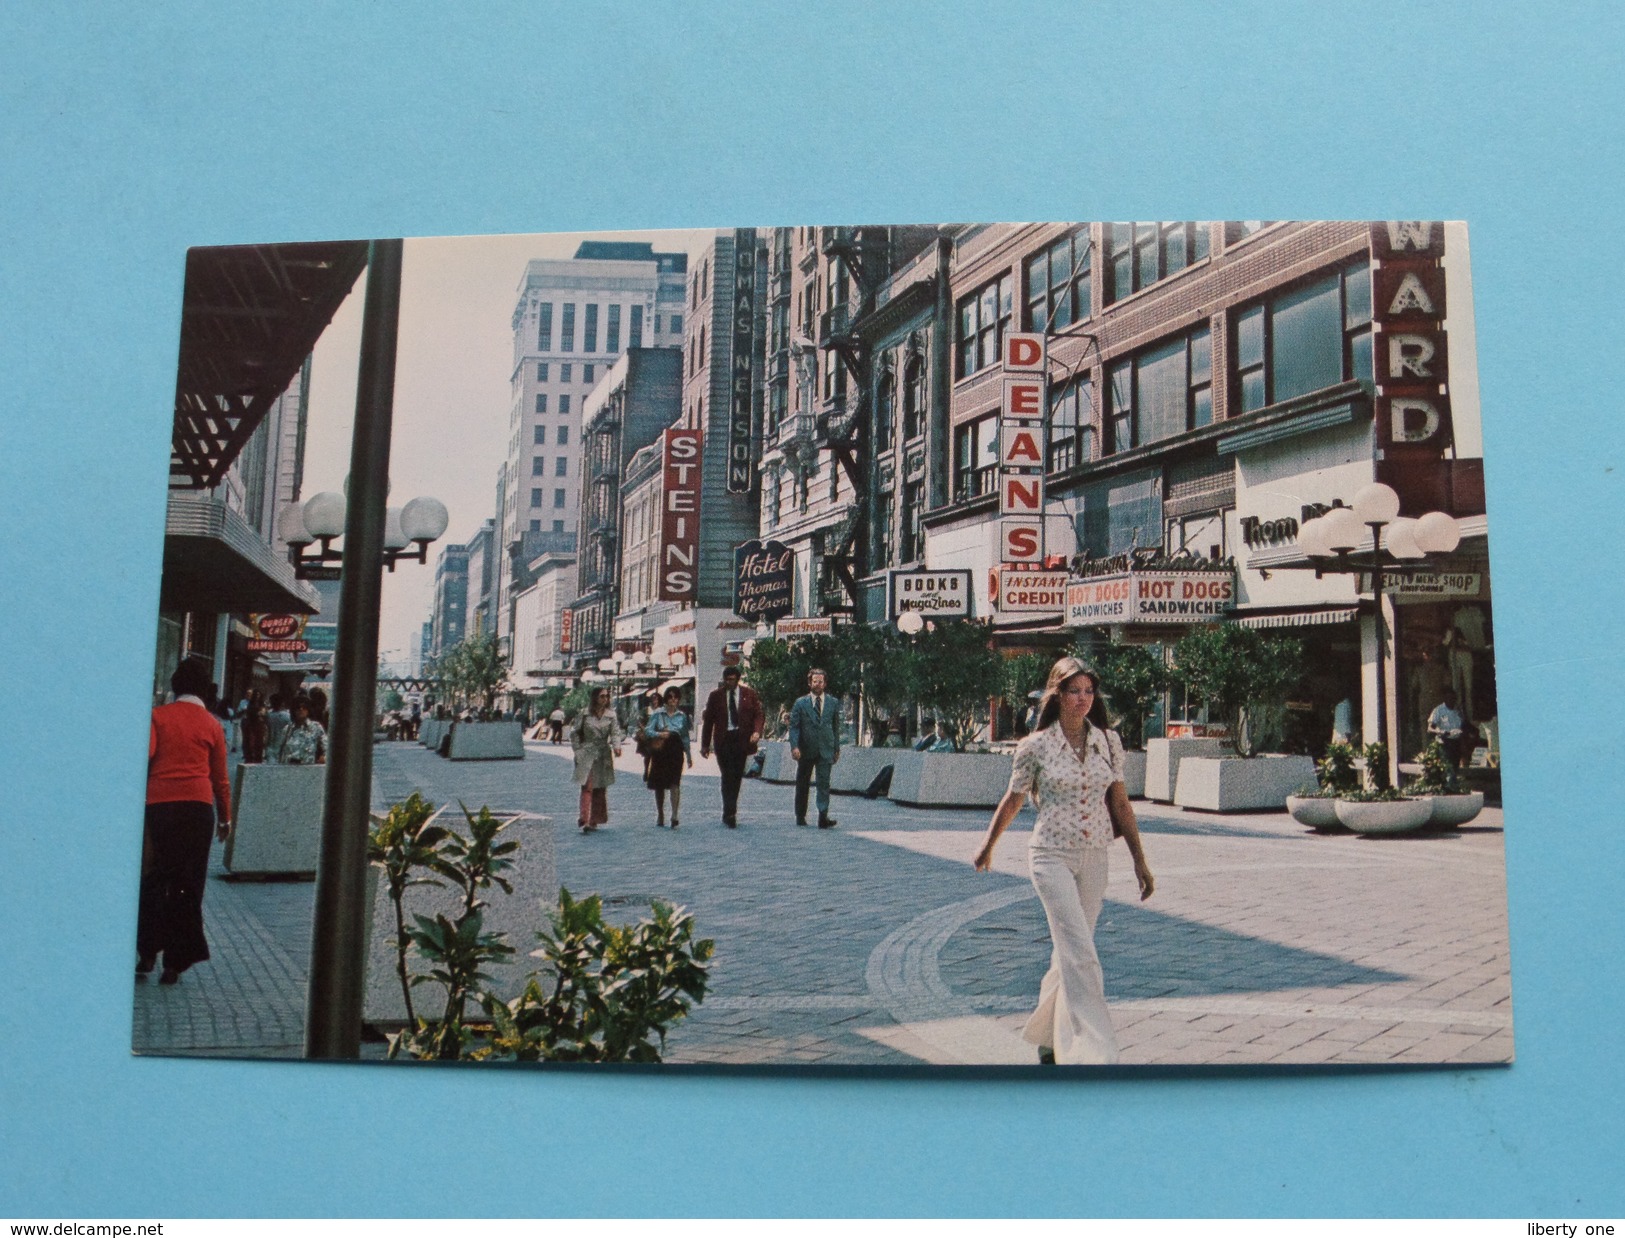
[{"x1": 130, "y1": 219, "x2": 1513, "y2": 1069}]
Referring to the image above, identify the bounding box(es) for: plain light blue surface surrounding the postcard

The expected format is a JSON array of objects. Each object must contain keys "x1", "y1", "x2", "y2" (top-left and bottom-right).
[{"x1": 0, "y1": 0, "x2": 1625, "y2": 1219}]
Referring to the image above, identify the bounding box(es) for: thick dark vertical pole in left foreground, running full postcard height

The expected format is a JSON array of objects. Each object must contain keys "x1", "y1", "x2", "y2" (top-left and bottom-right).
[{"x1": 306, "y1": 240, "x2": 401, "y2": 1058}]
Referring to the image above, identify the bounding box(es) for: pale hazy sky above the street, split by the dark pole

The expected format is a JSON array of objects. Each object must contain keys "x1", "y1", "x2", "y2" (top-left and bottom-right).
[{"x1": 302, "y1": 229, "x2": 715, "y2": 661}]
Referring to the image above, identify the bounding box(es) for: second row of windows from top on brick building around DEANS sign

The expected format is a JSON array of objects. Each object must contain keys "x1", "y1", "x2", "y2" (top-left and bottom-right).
[{"x1": 954, "y1": 258, "x2": 1372, "y2": 500}]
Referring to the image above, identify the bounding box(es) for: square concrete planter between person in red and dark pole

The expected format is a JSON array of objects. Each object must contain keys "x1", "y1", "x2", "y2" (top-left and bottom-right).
[{"x1": 226, "y1": 765, "x2": 327, "y2": 877}]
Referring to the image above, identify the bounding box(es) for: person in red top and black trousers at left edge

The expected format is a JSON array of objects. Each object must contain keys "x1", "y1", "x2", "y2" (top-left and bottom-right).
[{"x1": 135, "y1": 661, "x2": 231, "y2": 985}]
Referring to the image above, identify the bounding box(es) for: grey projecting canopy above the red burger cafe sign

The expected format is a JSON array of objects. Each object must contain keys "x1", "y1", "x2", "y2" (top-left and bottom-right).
[{"x1": 158, "y1": 491, "x2": 322, "y2": 614}]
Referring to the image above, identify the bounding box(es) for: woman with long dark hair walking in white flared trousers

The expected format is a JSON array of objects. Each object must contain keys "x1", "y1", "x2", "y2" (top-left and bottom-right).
[{"x1": 975, "y1": 658, "x2": 1155, "y2": 1066}]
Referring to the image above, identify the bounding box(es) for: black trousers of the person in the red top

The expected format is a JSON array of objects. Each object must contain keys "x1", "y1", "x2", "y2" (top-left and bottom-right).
[{"x1": 135, "y1": 801, "x2": 215, "y2": 972}]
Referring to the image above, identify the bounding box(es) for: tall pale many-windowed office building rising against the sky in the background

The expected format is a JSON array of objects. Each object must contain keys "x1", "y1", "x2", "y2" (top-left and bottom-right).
[{"x1": 494, "y1": 240, "x2": 687, "y2": 637}]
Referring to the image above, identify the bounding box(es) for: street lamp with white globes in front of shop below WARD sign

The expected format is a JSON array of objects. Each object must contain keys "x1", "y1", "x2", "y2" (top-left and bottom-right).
[{"x1": 1297, "y1": 481, "x2": 1461, "y2": 776}]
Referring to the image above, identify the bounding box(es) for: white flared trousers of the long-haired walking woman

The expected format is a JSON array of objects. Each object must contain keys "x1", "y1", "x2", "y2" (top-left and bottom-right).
[{"x1": 1022, "y1": 846, "x2": 1118, "y2": 1066}]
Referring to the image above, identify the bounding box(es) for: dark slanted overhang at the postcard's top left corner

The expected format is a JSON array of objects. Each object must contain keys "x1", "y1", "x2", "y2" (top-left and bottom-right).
[{"x1": 169, "y1": 240, "x2": 367, "y2": 491}]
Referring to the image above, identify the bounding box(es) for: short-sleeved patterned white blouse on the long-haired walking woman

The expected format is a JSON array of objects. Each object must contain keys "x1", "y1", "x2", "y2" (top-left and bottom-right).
[{"x1": 1009, "y1": 723, "x2": 1123, "y2": 851}]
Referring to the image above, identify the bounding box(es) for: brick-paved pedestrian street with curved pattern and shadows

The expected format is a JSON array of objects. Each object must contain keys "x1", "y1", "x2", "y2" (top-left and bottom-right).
[{"x1": 133, "y1": 744, "x2": 1511, "y2": 1064}]
